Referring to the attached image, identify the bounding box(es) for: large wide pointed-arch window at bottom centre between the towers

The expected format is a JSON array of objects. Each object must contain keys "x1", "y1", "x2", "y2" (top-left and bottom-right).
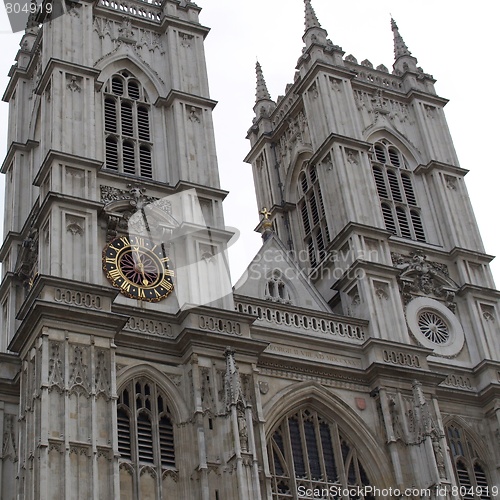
[{"x1": 267, "y1": 408, "x2": 373, "y2": 500}]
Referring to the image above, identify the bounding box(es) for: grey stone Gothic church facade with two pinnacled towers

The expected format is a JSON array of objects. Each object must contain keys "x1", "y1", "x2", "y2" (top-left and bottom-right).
[{"x1": 0, "y1": 0, "x2": 500, "y2": 500}]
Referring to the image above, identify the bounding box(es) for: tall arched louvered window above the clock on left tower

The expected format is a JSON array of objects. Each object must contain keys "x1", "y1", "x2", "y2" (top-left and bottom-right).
[{"x1": 104, "y1": 71, "x2": 153, "y2": 179}]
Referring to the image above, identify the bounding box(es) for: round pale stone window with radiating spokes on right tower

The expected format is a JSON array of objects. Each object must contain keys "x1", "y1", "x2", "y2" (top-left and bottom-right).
[{"x1": 406, "y1": 297, "x2": 464, "y2": 356}]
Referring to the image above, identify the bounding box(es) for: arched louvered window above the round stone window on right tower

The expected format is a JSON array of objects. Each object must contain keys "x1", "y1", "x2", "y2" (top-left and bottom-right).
[{"x1": 372, "y1": 140, "x2": 426, "y2": 241}]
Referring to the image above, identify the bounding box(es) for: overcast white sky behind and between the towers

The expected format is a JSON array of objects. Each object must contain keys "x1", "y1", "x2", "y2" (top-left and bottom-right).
[{"x1": 0, "y1": 0, "x2": 500, "y2": 284}]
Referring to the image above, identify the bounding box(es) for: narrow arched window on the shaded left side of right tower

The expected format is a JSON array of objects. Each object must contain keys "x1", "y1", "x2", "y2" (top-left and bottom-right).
[{"x1": 298, "y1": 163, "x2": 330, "y2": 268}]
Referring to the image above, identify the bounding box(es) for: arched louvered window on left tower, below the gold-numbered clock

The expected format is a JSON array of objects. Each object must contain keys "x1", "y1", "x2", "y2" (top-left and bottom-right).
[{"x1": 117, "y1": 378, "x2": 175, "y2": 472}]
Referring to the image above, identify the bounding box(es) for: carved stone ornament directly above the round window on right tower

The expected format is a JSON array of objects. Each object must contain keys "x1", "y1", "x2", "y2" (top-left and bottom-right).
[{"x1": 391, "y1": 250, "x2": 459, "y2": 312}]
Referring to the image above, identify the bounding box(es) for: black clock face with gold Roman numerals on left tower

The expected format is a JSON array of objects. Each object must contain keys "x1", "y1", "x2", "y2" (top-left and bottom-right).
[{"x1": 102, "y1": 236, "x2": 174, "y2": 302}]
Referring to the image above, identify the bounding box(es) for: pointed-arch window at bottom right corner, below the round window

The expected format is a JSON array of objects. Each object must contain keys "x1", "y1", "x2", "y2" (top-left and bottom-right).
[{"x1": 446, "y1": 423, "x2": 491, "y2": 500}]
